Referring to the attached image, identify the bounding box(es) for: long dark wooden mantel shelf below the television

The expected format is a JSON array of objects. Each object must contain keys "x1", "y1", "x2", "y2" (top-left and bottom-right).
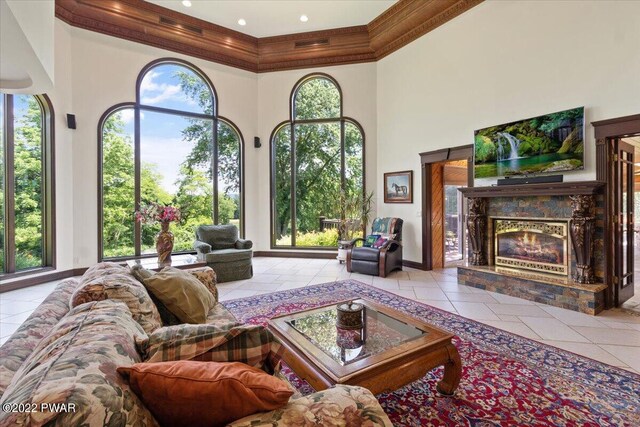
[{"x1": 459, "y1": 181, "x2": 605, "y2": 198}]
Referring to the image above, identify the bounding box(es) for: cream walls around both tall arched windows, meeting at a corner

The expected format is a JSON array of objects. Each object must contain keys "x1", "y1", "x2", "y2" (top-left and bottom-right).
[{"x1": 54, "y1": 25, "x2": 376, "y2": 268}]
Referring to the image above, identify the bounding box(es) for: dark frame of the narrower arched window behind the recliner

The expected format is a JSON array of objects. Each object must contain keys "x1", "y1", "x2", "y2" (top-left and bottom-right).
[{"x1": 269, "y1": 72, "x2": 367, "y2": 251}]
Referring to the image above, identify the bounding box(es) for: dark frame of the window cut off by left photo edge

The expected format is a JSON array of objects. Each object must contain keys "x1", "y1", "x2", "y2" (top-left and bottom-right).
[{"x1": 0, "y1": 93, "x2": 56, "y2": 280}]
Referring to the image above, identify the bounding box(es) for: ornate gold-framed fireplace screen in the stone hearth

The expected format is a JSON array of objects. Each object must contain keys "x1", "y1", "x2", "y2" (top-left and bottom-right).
[{"x1": 494, "y1": 219, "x2": 569, "y2": 276}]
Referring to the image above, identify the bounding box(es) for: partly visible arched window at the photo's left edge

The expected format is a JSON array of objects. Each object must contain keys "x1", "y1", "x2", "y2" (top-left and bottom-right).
[{"x1": 0, "y1": 94, "x2": 54, "y2": 277}]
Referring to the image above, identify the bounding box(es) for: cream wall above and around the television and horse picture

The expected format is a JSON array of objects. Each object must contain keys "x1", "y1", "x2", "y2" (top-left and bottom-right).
[{"x1": 377, "y1": 1, "x2": 640, "y2": 262}]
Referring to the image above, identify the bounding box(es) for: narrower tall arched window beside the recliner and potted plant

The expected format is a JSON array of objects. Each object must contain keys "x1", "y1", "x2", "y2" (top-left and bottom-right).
[{"x1": 271, "y1": 73, "x2": 364, "y2": 248}]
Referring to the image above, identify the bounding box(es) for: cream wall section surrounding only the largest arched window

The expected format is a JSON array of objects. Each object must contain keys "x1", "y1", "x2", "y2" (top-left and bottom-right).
[{"x1": 63, "y1": 24, "x2": 258, "y2": 267}]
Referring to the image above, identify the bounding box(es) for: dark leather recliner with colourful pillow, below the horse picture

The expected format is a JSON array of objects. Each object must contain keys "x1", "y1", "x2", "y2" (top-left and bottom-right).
[{"x1": 347, "y1": 218, "x2": 403, "y2": 277}]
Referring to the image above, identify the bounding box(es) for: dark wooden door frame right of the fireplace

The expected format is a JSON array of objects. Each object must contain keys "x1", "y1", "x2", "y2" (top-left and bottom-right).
[{"x1": 591, "y1": 114, "x2": 640, "y2": 309}]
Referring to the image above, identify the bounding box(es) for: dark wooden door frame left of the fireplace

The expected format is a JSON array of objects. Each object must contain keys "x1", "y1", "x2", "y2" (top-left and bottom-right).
[{"x1": 420, "y1": 144, "x2": 473, "y2": 270}]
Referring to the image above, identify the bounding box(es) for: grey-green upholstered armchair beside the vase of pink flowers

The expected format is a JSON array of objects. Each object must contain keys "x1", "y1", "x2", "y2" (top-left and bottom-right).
[{"x1": 193, "y1": 224, "x2": 253, "y2": 282}]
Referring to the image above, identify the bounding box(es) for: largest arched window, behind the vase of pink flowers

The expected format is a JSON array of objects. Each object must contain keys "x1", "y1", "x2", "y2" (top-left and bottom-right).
[{"x1": 99, "y1": 59, "x2": 244, "y2": 259}]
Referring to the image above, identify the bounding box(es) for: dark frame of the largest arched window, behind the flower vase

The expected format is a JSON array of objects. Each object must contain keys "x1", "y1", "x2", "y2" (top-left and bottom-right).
[{"x1": 98, "y1": 58, "x2": 245, "y2": 261}]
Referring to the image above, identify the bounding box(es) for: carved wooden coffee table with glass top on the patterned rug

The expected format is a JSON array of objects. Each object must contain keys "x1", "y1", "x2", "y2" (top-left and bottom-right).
[{"x1": 269, "y1": 299, "x2": 462, "y2": 395}]
